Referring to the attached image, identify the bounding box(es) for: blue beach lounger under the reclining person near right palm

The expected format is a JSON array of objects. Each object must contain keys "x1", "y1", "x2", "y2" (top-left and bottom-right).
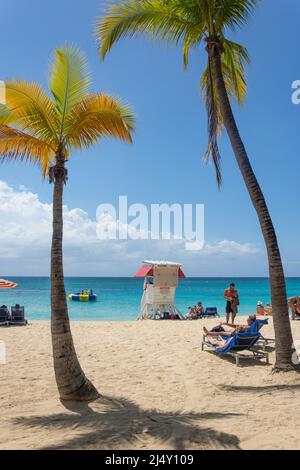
[{"x1": 201, "y1": 333, "x2": 269, "y2": 366}]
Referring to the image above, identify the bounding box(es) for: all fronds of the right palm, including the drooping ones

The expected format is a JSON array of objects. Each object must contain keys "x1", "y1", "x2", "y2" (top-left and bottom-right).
[{"x1": 95, "y1": 0, "x2": 260, "y2": 185}]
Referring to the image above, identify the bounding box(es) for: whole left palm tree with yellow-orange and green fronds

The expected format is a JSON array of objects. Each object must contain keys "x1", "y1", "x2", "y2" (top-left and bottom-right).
[{"x1": 0, "y1": 46, "x2": 134, "y2": 400}]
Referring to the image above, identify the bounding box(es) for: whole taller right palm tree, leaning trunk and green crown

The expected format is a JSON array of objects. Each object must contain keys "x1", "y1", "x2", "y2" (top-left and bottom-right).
[{"x1": 95, "y1": 0, "x2": 292, "y2": 370}]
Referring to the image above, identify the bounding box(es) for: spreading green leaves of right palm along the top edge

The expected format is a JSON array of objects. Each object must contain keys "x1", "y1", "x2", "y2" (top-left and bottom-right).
[{"x1": 95, "y1": 0, "x2": 260, "y2": 58}]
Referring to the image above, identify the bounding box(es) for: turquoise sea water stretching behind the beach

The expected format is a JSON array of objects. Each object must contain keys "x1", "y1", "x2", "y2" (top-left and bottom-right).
[{"x1": 0, "y1": 277, "x2": 300, "y2": 321}]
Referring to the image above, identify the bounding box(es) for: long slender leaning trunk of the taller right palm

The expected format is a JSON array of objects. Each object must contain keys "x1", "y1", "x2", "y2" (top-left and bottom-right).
[{"x1": 207, "y1": 40, "x2": 293, "y2": 370}]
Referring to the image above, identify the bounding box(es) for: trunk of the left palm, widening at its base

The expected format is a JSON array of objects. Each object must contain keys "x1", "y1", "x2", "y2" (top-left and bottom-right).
[{"x1": 51, "y1": 161, "x2": 99, "y2": 401}]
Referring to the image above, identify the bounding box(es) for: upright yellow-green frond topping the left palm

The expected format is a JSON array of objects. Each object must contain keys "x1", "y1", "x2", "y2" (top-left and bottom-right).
[{"x1": 49, "y1": 46, "x2": 90, "y2": 139}]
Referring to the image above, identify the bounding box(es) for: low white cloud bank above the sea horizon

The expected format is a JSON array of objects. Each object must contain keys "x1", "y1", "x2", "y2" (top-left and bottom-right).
[{"x1": 0, "y1": 180, "x2": 260, "y2": 276}]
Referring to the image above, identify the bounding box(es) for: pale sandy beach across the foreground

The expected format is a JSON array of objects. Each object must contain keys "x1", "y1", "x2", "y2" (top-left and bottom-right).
[{"x1": 0, "y1": 320, "x2": 300, "y2": 449}]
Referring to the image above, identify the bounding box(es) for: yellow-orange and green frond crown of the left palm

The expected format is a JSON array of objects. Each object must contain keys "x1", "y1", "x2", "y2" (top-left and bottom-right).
[{"x1": 0, "y1": 47, "x2": 135, "y2": 177}]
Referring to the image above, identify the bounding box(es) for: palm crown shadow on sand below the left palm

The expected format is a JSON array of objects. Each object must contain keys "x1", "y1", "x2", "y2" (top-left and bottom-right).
[{"x1": 12, "y1": 397, "x2": 241, "y2": 450}]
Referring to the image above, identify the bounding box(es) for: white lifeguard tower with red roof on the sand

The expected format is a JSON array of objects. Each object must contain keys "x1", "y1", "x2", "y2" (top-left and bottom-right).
[{"x1": 135, "y1": 261, "x2": 185, "y2": 320}]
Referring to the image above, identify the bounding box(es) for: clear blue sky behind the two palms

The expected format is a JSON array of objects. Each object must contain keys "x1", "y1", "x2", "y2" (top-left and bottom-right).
[{"x1": 0, "y1": 0, "x2": 300, "y2": 276}]
